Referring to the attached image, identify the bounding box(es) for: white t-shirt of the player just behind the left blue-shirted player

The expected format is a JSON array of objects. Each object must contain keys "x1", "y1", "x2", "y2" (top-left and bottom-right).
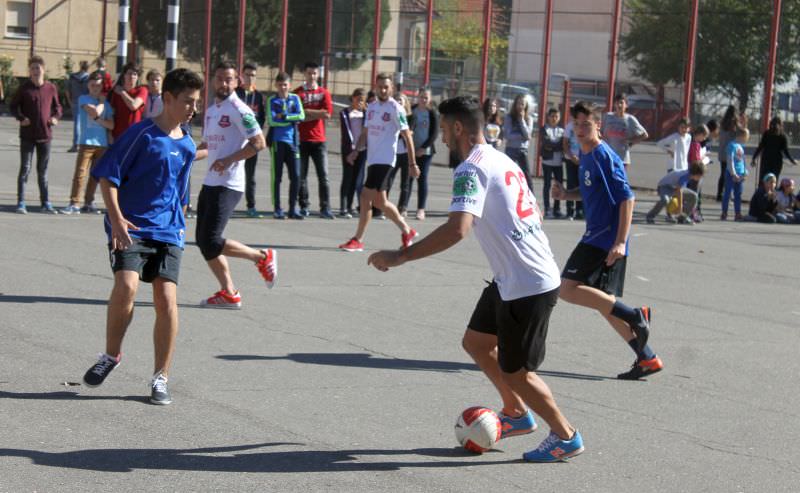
[{"x1": 203, "y1": 92, "x2": 261, "y2": 192}]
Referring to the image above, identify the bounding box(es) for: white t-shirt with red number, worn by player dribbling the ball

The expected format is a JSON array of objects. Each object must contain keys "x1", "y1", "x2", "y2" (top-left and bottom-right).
[{"x1": 450, "y1": 144, "x2": 561, "y2": 301}]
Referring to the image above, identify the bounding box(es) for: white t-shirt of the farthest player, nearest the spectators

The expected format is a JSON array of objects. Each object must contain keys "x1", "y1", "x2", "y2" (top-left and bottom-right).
[{"x1": 365, "y1": 98, "x2": 408, "y2": 167}]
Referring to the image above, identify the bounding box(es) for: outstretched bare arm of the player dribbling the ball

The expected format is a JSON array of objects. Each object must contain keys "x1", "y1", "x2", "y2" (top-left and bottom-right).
[{"x1": 367, "y1": 212, "x2": 475, "y2": 272}]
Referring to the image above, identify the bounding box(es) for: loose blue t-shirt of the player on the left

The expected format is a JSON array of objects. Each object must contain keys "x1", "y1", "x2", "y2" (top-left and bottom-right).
[{"x1": 92, "y1": 118, "x2": 197, "y2": 248}]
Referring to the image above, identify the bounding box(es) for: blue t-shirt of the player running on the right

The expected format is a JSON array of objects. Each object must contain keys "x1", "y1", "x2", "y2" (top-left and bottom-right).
[{"x1": 578, "y1": 141, "x2": 634, "y2": 255}]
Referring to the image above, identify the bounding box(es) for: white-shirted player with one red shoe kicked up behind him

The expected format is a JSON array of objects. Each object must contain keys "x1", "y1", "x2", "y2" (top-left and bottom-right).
[{"x1": 195, "y1": 62, "x2": 278, "y2": 308}]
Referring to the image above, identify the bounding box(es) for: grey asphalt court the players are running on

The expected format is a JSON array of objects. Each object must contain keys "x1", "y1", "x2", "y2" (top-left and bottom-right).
[{"x1": 0, "y1": 119, "x2": 800, "y2": 492}]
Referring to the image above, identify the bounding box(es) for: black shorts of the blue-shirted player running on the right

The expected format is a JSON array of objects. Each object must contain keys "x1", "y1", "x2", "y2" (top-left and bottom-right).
[{"x1": 561, "y1": 243, "x2": 628, "y2": 297}]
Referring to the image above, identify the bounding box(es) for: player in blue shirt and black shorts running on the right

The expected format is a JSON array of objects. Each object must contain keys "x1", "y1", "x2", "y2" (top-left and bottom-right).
[{"x1": 552, "y1": 102, "x2": 664, "y2": 380}]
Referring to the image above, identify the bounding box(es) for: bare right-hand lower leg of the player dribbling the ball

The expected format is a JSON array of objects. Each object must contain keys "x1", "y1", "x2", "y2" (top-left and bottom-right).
[{"x1": 502, "y1": 368, "x2": 575, "y2": 440}]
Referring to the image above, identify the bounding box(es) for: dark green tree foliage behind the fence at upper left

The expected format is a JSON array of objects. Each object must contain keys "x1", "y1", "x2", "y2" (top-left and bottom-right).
[{"x1": 137, "y1": 0, "x2": 391, "y2": 69}]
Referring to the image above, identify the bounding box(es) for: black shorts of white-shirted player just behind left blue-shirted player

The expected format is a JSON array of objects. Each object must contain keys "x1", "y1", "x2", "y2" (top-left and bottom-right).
[{"x1": 195, "y1": 185, "x2": 242, "y2": 260}]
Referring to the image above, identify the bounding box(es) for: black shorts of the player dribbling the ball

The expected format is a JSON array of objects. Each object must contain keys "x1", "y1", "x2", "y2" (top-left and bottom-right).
[{"x1": 469, "y1": 282, "x2": 558, "y2": 373}]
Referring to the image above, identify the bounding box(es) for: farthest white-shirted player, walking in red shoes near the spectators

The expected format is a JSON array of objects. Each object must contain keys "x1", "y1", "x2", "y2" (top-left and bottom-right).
[{"x1": 339, "y1": 73, "x2": 419, "y2": 252}]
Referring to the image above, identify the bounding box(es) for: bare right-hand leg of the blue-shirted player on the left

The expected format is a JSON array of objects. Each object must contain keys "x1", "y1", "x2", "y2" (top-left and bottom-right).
[{"x1": 153, "y1": 277, "x2": 178, "y2": 376}]
